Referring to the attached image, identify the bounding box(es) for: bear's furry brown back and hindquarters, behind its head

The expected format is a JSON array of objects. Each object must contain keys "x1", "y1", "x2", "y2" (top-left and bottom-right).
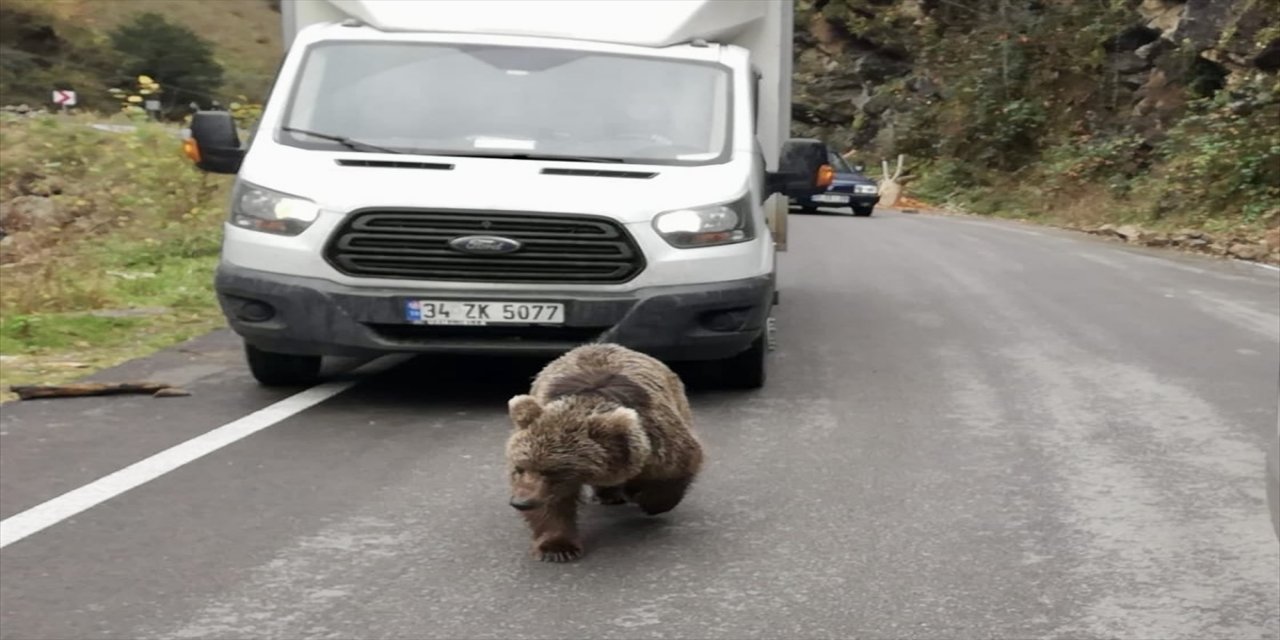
[{"x1": 531, "y1": 344, "x2": 703, "y2": 479}]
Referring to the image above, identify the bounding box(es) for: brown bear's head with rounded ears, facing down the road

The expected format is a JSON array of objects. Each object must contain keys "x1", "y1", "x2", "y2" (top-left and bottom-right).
[{"x1": 507, "y1": 396, "x2": 652, "y2": 511}]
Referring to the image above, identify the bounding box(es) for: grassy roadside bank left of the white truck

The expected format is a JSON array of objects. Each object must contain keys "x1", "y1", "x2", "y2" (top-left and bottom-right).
[{"x1": 0, "y1": 110, "x2": 230, "y2": 402}]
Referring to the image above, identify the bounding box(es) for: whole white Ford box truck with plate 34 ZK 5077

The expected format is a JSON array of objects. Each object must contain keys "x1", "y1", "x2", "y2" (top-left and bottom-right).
[{"x1": 187, "y1": 0, "x2": 831, "y2": 388}]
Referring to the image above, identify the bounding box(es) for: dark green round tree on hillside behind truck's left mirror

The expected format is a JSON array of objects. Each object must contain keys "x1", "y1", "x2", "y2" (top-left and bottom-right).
[{"x1": 110, "y1": 13, "x2": 223, "y2": 113}]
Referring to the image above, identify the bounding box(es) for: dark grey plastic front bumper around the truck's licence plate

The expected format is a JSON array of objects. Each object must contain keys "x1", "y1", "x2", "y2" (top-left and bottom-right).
[{"x1": 215, "y1": 262, "x2": 776, "y2": 361}]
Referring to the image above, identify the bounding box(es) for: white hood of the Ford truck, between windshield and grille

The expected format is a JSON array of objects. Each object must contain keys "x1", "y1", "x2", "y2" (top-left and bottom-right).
[{"x1": 239, "y1": 141, "x2": 751, "y2": 223}]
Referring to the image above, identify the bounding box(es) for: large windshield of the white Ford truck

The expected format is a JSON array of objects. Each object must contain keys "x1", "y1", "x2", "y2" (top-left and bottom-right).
[{"x1": 280, "y1": 42, "x2": 731, "y2": 164}]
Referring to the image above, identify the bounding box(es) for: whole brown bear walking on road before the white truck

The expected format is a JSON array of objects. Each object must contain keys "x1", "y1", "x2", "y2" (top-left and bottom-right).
[{"x1": 507, "y1": 344, "x2": 703, "y2": 562}]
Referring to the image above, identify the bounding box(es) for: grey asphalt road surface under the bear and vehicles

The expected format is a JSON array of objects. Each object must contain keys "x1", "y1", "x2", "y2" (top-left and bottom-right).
[{"x1": 0, "y1": 211, "x2": 1280, "y2": 640}]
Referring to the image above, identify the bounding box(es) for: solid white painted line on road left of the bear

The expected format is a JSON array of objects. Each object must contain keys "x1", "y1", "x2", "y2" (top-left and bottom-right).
[{"x1": 0, "y1": 356, "x2": 408, "y2": 549}]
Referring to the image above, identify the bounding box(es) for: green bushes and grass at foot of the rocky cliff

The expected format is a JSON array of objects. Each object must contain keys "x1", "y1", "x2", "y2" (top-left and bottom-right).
[{"x1": 911, "y1": 90, "x2": 1280, "y2": 254}]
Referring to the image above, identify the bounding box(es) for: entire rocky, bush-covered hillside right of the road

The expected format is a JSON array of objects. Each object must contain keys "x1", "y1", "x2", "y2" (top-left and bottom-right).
[{"x1": 792, "y1": 0, "x2": 1280, "y2": 245}]
